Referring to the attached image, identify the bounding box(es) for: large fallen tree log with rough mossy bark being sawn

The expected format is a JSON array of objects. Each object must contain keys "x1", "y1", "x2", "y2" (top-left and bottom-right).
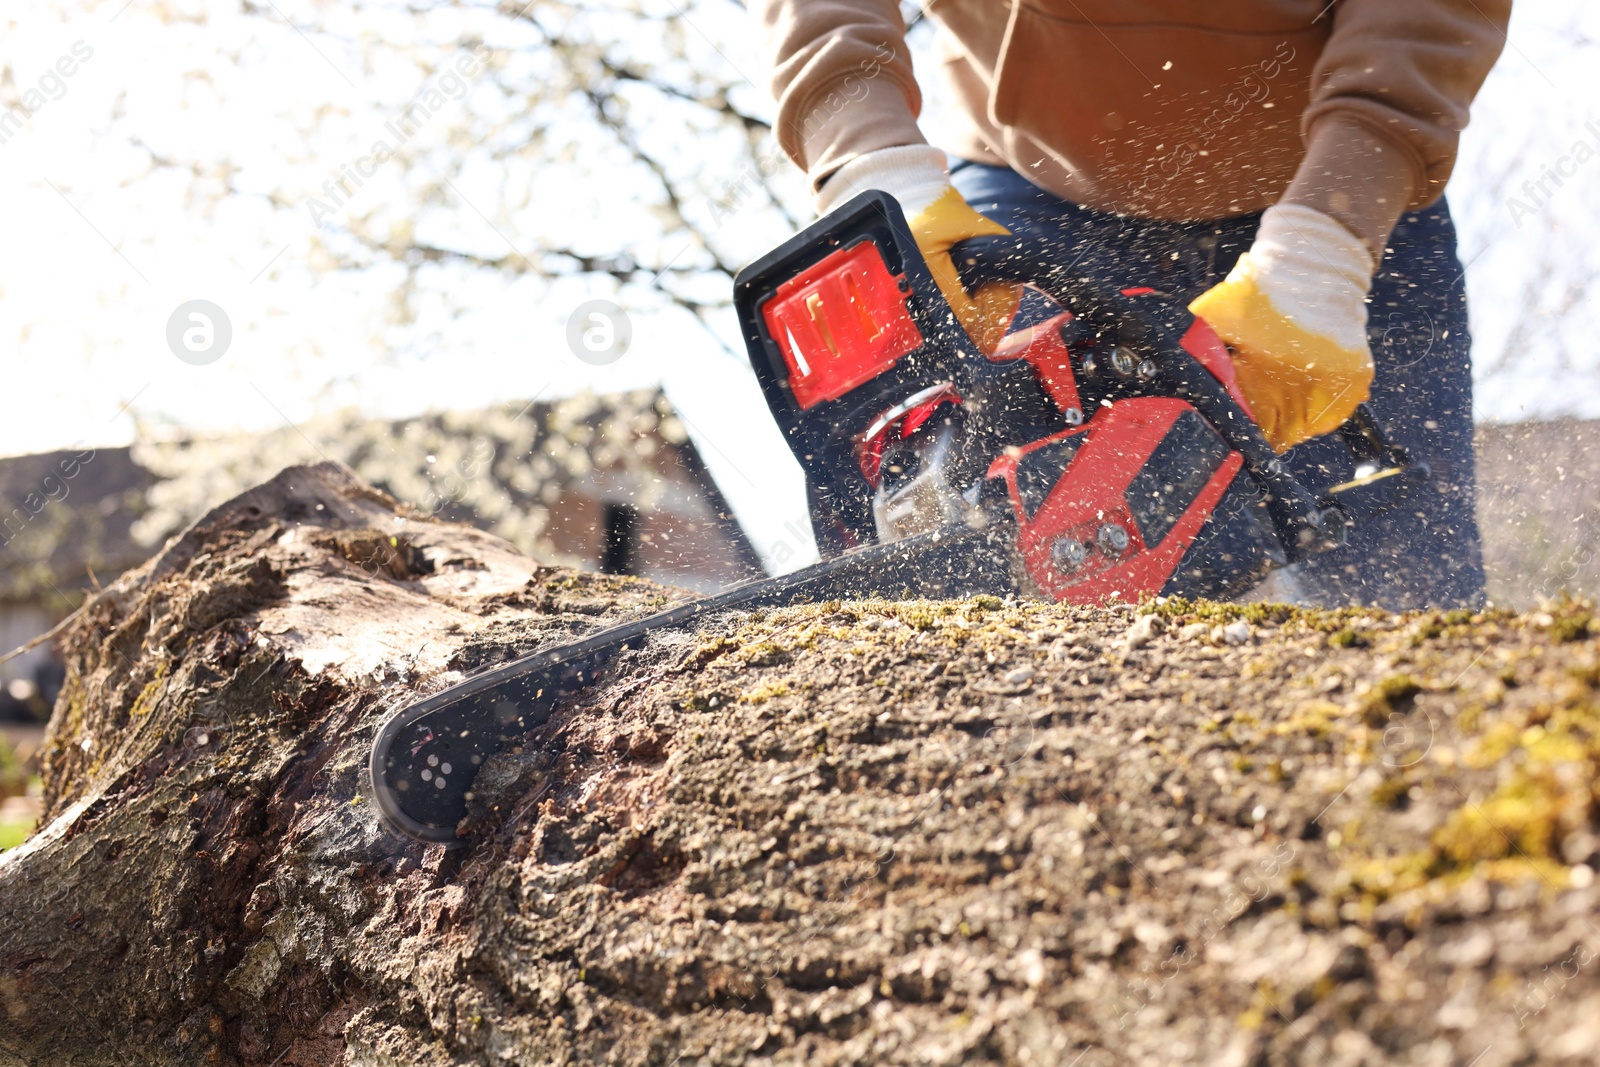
[{"x1": 0, "y1": 464, "x2": 1600, "y2": 1067}]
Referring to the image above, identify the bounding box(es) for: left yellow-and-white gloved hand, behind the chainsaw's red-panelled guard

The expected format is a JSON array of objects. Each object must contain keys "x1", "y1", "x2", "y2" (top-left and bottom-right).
[{"x1": 816, "y1": 144, "x2": 1021, "y2": 354}]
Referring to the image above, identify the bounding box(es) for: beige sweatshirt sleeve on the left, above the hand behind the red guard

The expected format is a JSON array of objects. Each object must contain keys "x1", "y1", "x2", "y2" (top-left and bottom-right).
[{"x1": 750, "y1": 0, "x2": 926, "y2": 187}]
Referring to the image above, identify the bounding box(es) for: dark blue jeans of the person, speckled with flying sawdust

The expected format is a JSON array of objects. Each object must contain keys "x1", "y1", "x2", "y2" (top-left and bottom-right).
[{"x1": 952, "y1": 160, "x2": 1483, "y2": 611}]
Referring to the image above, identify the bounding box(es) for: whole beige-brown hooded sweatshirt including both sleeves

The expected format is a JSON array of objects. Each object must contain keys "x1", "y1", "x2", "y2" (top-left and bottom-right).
[{"x1": 750, "y1": 0, "x2": 1510, "y2": 248}]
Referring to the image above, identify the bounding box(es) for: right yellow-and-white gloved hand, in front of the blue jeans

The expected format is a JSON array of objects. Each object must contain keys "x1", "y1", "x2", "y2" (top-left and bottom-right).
[{"x1": 1189, "y1": 203, "x2": 1374, "y2": 453}]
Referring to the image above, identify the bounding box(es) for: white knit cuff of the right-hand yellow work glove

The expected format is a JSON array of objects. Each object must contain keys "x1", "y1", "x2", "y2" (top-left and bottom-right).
[{"x1": 1229, "y1": 203, "x2": 1374, "y2": 350}]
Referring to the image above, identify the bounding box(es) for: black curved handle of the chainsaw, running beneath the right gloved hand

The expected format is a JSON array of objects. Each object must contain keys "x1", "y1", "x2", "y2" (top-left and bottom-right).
[{"x1": 950, "y1": 234, "x2": 1342, "y2": 553}]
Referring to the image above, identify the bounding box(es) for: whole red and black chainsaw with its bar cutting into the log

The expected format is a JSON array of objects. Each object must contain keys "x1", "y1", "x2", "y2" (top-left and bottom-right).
[{"x1": 370, "y1": 192, "x2": 1430, "y2": 843}]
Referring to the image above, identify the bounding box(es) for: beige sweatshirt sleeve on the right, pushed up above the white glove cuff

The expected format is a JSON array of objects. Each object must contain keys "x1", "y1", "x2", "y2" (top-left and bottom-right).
[{"x1": 1285, "y1": 0, "x2": 1510, "y2": 250}]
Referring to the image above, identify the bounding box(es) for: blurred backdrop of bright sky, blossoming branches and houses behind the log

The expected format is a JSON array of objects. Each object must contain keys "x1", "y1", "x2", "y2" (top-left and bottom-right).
[{"x1": 0, "y1": 0, "x2": 1600, "y2": 848}]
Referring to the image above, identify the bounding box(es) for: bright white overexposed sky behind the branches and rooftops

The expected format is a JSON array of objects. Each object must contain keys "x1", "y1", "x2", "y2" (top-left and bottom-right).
[{"x1": 0, "y1": 0, "x2": 1600, "y2": 566}]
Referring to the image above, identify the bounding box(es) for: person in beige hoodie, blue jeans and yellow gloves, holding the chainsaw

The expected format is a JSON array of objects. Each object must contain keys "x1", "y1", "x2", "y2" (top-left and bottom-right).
[{"x1": 752, "y1": 0, "x2": 1510, "y2": 608}]
